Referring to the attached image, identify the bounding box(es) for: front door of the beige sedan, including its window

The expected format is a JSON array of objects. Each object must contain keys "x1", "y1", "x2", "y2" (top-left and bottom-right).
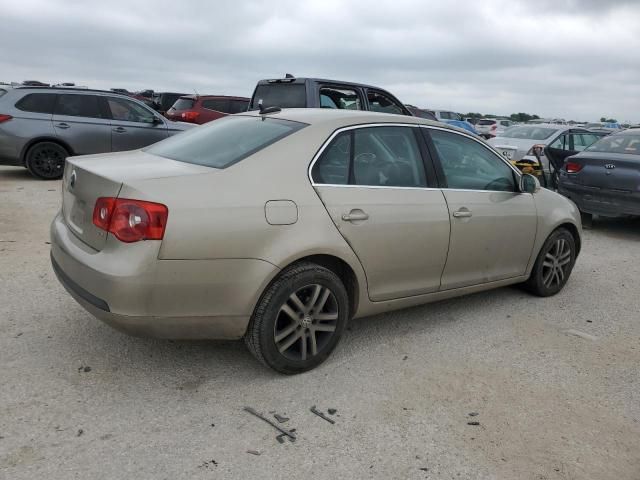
[{"x1": 427, "y1": 128, "x2": 537, "y2": 290}]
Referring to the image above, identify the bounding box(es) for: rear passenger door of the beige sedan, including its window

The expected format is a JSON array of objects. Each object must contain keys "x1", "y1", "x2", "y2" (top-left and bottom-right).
[{"x1": 311, "y1": 126, "x2": 449, "y2": 301}]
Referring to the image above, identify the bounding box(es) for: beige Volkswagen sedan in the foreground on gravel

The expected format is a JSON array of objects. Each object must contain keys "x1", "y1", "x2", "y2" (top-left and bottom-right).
[{"x1": 51, "y1": 107, "x2": 581, "y2": 373}]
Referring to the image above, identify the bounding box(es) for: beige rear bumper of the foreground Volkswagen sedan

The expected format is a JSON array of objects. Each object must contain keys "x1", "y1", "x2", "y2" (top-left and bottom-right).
[{"x1": 51, "y1": 215, "x2": 278, "y2": 339}]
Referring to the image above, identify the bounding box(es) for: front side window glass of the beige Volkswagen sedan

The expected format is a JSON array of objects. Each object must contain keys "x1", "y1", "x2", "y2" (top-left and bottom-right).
[{"x1": 429, "y1": 130, "x2": 516, "y2": 192}]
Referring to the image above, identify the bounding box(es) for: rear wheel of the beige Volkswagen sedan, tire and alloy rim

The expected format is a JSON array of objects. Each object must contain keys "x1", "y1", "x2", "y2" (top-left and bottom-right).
[{"x1": 244, "y1": 262, "x2": 349, "y2": 375}]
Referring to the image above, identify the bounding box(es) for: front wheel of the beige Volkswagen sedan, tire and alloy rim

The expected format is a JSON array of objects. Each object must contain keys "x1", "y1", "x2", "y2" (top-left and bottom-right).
[{"x1": 524, "y1": 228, "x2": 576, "y2": 297}]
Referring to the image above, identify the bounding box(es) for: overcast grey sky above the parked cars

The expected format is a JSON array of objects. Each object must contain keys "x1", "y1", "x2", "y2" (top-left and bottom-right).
[{"x1": 0, "y1": 0, "x2": 640, "y2": 122}]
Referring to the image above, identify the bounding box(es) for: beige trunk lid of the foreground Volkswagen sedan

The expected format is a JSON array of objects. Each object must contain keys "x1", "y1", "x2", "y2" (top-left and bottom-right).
[{"x1": 62, "y1": 151, "x2": 213, "y2": 250}]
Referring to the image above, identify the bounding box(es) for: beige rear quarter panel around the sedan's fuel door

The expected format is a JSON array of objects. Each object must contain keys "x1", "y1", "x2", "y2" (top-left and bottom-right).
[{"x1": 120, "y1": 127, "x2": 366, "y2": 314}]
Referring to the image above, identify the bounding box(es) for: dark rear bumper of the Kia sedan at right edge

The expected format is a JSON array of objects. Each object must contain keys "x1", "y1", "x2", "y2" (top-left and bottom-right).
[{"x1": 558, "y1": 180, "x2": 640, "y2": 217}]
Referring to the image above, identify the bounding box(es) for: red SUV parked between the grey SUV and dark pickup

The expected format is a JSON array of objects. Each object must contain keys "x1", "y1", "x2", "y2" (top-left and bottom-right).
[{"x1": 165, "y1": 95, "x2": 250, "y2": 125}]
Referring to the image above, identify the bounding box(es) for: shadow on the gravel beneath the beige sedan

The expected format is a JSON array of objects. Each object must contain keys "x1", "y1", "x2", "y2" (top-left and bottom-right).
[{"x1": 59, "y1": 288, "x2": 528, "y2": 382}]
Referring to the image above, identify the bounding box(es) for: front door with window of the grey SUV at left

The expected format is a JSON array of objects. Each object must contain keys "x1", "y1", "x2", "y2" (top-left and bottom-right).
[{"x1": 104, "y1": 97, "x2": 169, "y2": 152}]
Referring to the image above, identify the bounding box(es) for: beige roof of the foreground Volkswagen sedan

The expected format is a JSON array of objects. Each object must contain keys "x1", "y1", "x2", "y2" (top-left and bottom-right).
[{"x1": 238, "y1": 108, "x2": 462, "y2": 134}]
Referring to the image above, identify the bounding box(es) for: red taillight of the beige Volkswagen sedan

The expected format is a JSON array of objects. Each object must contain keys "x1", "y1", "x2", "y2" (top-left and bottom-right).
[{"x1": 93, "y1": 197, "x2": 169, "y2": 243}]
